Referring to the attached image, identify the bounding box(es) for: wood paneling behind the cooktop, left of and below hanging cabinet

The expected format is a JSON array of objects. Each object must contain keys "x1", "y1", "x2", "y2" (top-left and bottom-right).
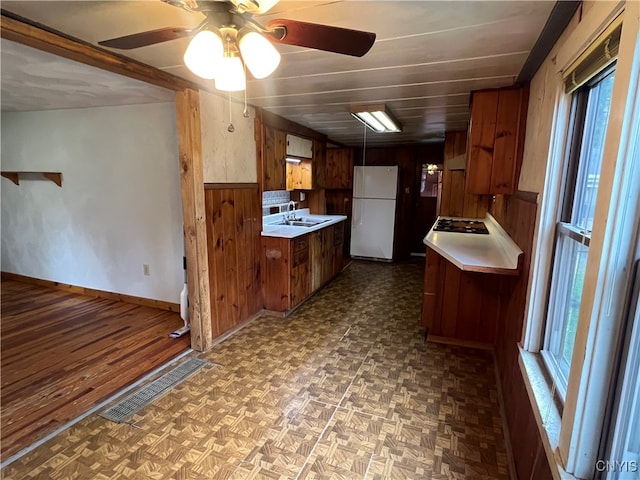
[{"x1": 439, "y1": 131, "x2": 491, "y2": 218}]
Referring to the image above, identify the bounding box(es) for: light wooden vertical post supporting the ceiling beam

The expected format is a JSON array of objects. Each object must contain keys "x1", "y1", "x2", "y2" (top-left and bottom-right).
[{"x1": 176, "y1": 89, "x2": 213, "y2": 351}]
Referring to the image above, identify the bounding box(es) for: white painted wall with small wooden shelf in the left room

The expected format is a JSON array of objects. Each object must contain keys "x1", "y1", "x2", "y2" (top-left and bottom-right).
[{"x1": 1, "y1": 103, "x2": 184, "y2": 302}]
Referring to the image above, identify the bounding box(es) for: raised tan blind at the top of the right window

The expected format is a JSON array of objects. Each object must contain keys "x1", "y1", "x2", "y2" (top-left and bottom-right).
[{"x1": 564, "y1": 22, "x2": 622, "y2": 93}]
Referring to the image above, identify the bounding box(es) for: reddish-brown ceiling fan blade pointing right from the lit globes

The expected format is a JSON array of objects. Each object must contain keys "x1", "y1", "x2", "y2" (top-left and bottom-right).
[{"x1": 266, "y1": 19, "x2": 376, "y2": 57}]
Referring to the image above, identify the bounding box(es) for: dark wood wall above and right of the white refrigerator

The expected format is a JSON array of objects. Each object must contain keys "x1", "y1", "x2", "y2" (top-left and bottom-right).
[{"x1": 354, "y1": 143, "x2": 443, "y2": 260}]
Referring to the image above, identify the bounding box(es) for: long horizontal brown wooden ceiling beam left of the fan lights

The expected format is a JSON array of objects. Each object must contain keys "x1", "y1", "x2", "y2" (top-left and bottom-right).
[{"x1": 0, "y1": 11, "x2": 202, "y2": 91}]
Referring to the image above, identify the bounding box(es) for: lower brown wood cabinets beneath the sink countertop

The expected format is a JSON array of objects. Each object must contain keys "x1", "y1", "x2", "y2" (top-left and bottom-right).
[{"x1": 262, "y1": 222, "x2": 344, "y2": 312}]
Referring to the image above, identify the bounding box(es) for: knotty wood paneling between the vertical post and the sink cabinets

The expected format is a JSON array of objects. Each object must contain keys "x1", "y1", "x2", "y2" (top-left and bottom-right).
[{"x1": 205, "y1": 184, "x2": 262, "y2": 338}]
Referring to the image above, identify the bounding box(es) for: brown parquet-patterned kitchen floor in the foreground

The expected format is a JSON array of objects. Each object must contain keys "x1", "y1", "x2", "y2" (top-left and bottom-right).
[{"x1": 2, "y1": 262, "x2": 510, "y2": 480}]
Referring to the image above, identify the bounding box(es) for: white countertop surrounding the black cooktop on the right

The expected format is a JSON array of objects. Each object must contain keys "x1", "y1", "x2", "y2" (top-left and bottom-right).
[{"x1": 424, "y1": 214, "x2": 522, "y2": 275}]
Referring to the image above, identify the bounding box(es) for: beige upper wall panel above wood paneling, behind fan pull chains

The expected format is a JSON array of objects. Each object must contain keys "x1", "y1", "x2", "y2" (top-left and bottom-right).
[{"x1": 200, "y1": 90, "x2": 258, "y2": 183}]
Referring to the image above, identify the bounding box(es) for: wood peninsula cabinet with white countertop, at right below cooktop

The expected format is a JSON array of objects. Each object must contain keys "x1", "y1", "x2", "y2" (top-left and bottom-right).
[{"x1": 422, "y1": 214, "x2": 523, "y2": 345}]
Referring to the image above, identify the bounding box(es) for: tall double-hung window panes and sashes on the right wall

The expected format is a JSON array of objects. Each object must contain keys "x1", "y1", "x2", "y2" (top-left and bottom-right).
[{"x1": 542, "y1": 67, "x2": 614, "y2": 399}]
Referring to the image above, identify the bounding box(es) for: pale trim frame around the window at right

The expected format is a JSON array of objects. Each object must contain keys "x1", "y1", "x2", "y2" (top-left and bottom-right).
[{"x1": 519, "y1": 2, "x2": 640, "y2": 479}]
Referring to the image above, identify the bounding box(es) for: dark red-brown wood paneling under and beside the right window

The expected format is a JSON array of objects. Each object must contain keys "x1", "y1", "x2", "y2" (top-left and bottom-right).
[{"x1": 490, "y1": 192, "x2": 552, "y2": 480}]
